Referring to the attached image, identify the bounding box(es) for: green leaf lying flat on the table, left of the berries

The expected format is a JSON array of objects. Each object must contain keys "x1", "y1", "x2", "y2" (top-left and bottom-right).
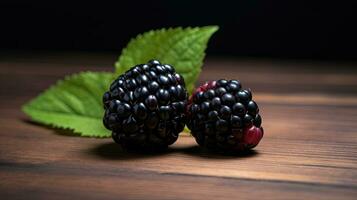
[{"x1": 22, "y1": 72, "x2": 113, "y2": 137}]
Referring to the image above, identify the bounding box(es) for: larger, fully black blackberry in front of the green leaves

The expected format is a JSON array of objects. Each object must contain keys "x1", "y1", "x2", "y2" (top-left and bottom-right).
[{"x1": 103, "y1": 60, "x2": 188, "y2": 149}]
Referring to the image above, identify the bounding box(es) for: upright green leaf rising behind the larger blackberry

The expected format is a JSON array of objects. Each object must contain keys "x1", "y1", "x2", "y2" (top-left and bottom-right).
[{"x1": 115, "y1": 26, "x2": 218, "y2": 92}]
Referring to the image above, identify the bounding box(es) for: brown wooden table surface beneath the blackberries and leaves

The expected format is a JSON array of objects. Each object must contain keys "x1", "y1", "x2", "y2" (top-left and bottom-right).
[{"x1": 0, "y1": 52, "x2": 357, "y2": 199}]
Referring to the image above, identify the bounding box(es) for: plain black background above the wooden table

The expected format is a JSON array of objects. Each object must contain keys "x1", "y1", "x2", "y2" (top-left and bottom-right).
[{"x1": 0, "y1": 0, "x2": 357, "y2": 60}]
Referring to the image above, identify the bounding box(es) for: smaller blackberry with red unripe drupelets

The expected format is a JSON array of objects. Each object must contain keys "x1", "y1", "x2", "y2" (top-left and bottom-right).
[{"x1": 186, "y1": 79, "x2": 264, "y2": 152}]
